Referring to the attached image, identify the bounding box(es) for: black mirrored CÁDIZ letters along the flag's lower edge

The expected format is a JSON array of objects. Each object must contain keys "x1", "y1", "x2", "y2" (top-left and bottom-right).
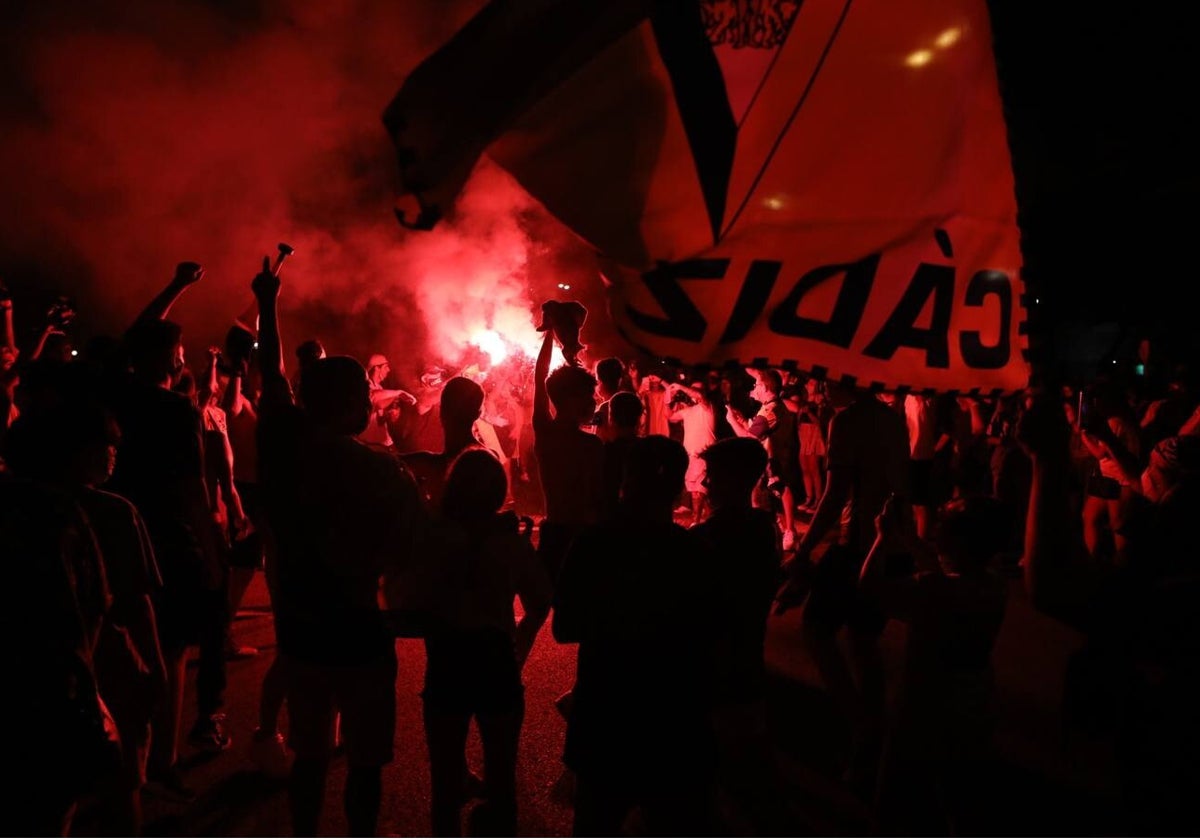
[{"x1": 625, "y1": 246, "x2": 1013, "y2": 370}]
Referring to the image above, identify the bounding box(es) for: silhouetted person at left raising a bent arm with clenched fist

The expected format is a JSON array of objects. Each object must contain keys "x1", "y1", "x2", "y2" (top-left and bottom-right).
[{"x1": 108, "y1": 263, "x2": 232, "y2": 800}]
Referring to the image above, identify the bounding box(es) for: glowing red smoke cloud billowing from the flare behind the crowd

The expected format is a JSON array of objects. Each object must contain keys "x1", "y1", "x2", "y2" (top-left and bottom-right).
[{"x1": 0, "y1": 0, "x2": 604, "y2": 378}]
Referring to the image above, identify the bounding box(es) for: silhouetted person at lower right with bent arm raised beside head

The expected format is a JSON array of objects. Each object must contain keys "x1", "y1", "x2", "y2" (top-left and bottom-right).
[{"x1": 860, "y1": 496, "x2": 1009, "y2": 836}]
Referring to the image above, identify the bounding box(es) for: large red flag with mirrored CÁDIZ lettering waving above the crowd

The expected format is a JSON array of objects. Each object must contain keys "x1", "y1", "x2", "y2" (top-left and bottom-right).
[{"x1": 384, "y1": 0, "x2": 1028, "y2": 392}]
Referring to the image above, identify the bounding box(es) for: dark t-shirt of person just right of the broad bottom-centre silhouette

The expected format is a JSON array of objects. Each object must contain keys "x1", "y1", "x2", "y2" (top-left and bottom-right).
[{"x1": 692, "y1": 508, "x2": 784, "y2": 702}]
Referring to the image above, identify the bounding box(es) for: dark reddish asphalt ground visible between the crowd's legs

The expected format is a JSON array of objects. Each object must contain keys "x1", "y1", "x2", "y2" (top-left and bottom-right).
[{"x1": 77, "y1": 508, "x2": 1120, "y2": 836}]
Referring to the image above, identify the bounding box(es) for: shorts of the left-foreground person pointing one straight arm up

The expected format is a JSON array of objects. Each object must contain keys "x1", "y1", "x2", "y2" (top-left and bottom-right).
[{"x1": 284, "y1": 652, "x2": 396, "y2": 767}]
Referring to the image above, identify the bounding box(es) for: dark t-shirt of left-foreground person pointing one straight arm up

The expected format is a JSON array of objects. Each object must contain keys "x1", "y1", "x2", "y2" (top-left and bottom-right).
[{"x1": 258, "y1": 398, "x2": 420, "y2": 665}]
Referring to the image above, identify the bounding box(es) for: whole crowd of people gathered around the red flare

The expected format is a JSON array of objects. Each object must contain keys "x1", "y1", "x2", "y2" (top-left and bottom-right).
[{"x1": 0, "y1": 259, "x2": 1200, "y2": 836}]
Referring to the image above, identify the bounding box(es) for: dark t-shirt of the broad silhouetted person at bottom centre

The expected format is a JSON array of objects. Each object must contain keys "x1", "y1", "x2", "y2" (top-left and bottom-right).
[{"x1": 553, "y1": 518, "x2": 719, "y2": 785}]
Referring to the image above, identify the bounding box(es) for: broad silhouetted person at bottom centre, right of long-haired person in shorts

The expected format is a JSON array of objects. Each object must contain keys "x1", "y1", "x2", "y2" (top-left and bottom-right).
[{"x1": 553, "y1": 436, "x2": 721, "y2": 836}]
